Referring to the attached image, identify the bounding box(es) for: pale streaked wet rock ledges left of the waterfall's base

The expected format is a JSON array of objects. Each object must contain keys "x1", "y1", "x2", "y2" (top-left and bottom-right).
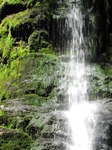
[{"x1": 0, "y1": 96, "x2": 70, "y2": 150}]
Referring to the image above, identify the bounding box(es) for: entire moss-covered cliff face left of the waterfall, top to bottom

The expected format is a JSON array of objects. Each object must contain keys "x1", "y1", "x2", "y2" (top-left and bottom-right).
[{"x1": 0, "y1": 0, "x2": 64, "y2": 150}]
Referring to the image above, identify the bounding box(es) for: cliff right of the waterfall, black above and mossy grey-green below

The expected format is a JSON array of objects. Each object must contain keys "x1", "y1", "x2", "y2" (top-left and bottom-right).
[{"x1": 83, "y1": 0, "x2": 112, "y2": 99}]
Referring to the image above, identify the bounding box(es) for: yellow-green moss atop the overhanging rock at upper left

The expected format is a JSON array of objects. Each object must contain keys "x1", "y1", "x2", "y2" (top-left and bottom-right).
[{"x1": 0, "y1": 8, "x2": 40, "y2": 36}]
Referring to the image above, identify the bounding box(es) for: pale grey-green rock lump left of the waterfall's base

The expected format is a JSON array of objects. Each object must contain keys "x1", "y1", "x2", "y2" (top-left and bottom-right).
[{"x1": 26, "y1": 112, "x2": 56, "y2": 138}]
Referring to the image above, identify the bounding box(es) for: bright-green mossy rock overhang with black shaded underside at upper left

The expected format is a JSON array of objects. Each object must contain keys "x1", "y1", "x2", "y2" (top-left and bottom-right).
[{"x1": 0, "y1": 8, "x2": 40, "y2": 40}]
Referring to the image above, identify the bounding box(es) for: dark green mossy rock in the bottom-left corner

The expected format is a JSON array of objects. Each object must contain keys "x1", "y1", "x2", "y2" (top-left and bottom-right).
[{"x1": 0, "y1": 128, "x2": 31, "y2": 150}]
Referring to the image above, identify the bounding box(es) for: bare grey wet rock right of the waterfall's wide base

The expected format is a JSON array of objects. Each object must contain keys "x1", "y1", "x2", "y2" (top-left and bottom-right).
[{"x1": 93, "y1": 100, "x2": 112, "y2": 150}]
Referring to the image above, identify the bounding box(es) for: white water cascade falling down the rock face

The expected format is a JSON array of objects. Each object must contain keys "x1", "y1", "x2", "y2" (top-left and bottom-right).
[{"x1": 61, "y1": 0, "x2": 96, "y2": 150}]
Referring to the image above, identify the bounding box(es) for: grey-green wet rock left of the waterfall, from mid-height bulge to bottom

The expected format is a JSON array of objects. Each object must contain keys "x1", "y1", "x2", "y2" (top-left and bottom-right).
[{"x1": 0, "y1": 50, "x2": 67, "y2": 150}]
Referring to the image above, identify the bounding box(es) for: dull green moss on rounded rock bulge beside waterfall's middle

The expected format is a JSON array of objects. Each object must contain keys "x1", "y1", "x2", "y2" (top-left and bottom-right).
[{"x1": 20, "y1": 54, "x2": 59, "y2": 101}]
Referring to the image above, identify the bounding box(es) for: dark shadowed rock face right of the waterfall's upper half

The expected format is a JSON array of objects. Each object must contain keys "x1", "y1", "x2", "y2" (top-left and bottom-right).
[{"x1": 83, "y1": 0, "x2": 112, "y2": 62}]
